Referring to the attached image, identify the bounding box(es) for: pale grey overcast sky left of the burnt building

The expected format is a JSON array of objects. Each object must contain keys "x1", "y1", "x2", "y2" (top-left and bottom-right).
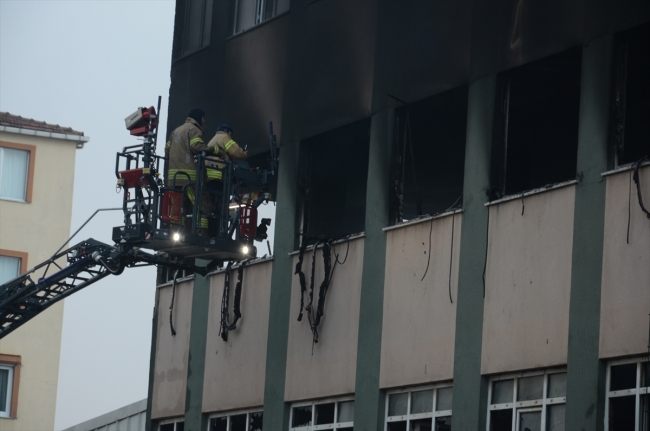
[{"x1": 0, "y1": 0, "x2": 266, "y2": 430}]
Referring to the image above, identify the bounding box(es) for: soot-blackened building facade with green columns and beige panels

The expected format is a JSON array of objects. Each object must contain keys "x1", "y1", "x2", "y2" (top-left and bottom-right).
[{"x1": 147, "y1": 0, "x2": 650, "y2": 431}]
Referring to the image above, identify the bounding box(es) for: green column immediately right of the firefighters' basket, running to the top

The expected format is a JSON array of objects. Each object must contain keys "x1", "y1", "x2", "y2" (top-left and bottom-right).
[{"x1": 264, "y1": 0, "x2": 309, "y2": 430}]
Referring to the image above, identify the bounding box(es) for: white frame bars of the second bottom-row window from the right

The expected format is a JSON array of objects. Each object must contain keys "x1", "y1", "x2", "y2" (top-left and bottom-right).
[{"x1": 485, "y1": 367, "x2": 567, "y2": 431}]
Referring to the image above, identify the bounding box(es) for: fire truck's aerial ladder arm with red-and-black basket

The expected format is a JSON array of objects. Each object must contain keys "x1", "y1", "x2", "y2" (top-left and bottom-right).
[{"x1": 0, "y1": 97, "x2": 277, "y2": 339}]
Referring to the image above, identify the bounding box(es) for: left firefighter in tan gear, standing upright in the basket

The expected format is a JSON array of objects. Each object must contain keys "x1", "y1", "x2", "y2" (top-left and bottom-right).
[{"x1": 165, "y1": 108, "x2": 225, "y2": 235}]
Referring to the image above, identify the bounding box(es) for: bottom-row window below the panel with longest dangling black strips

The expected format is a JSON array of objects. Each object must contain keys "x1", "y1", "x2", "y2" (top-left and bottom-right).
[{"x1": 289, "y1": 398, "x2": 354, "y2": 431}]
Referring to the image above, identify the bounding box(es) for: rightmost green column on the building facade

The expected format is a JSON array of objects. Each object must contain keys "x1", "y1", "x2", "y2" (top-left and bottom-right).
[{"x1": 566, "y1": 36, "x2": 612, "y2": 430}]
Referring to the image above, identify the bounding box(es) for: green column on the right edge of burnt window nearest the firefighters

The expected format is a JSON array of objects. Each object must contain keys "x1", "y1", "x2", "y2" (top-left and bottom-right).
[{"x1": 354, "y1": 109, "x2": 394, "y2": 431}]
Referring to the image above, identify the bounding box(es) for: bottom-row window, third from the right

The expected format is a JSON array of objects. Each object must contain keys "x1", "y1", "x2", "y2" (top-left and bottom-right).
[{"x1": 385, "y1": 383, "x2": 453, "y2": 431}]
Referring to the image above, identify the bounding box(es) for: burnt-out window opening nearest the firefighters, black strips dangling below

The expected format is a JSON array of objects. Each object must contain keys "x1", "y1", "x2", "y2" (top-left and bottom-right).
[{"x1": 298, "y1": 120, "x2": 370, "y2": 244}]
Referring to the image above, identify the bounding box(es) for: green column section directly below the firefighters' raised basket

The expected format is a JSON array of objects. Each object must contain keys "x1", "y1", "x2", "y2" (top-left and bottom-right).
[{"x1": 185, "y1": 268, "x2": 210, "y2": 431}]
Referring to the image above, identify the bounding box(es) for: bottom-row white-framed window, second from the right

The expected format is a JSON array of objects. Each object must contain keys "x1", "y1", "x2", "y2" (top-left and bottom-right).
[{"x1": 488, "y1": 370, "x2": 566, "y2": 431}]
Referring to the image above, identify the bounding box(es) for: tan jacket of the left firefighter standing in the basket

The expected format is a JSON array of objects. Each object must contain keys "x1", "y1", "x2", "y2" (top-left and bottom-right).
[{"x1": 165, "y1": 118, "x2": 220, "y2": 185}]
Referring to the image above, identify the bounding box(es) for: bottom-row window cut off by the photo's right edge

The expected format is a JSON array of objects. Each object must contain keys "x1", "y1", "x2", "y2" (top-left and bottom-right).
[{"x1": 605, "y1": 358, "x2": 650, "y2": 431}]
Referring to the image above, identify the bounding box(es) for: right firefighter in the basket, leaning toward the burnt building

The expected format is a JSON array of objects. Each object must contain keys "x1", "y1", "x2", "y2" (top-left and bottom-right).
[{"x1": 207, "y1": 124, "x2": 248, "y2": 236}]
